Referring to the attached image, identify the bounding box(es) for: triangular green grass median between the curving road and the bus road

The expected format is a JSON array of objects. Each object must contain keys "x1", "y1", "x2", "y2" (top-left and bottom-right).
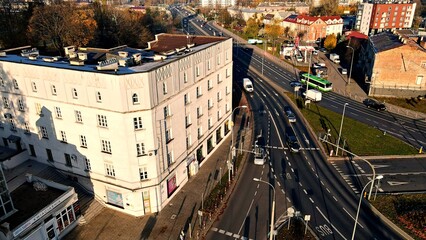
[{"x1": 288, "y1": 93, "x2": 418, "y2": 156}]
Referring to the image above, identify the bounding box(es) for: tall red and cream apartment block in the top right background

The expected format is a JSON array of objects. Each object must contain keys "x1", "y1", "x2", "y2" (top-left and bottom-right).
[{"x1": 355, "y1": 0, "x2": 416, "y2": 35}]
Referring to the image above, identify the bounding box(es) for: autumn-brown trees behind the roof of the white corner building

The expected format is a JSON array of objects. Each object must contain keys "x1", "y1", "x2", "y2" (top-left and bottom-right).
[{"x1": 0, "y1": 0, "x2": 173, "y2": 55}]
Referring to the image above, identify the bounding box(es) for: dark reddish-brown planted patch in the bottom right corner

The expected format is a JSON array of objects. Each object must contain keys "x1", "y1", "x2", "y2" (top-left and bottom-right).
[{"x1": 372, "y1": 194, "x2": 426, "y2": 239}]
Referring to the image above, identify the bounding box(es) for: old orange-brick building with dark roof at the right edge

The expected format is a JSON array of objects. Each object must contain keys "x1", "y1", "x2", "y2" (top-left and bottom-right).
[{"x1": 356, "y1": 32, "x2": 426, "y2": 97}]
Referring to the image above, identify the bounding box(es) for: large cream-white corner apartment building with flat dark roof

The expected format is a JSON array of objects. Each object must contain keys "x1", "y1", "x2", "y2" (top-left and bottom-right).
[{"x1": 0, "y1": 34, "x2": 233, "y2": 216}]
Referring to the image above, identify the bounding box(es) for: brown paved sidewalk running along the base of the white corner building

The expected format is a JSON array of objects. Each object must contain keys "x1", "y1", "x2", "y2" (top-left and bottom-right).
[{"x1": 64, "y1": 100, "x2": 253, "y2": 240}]
